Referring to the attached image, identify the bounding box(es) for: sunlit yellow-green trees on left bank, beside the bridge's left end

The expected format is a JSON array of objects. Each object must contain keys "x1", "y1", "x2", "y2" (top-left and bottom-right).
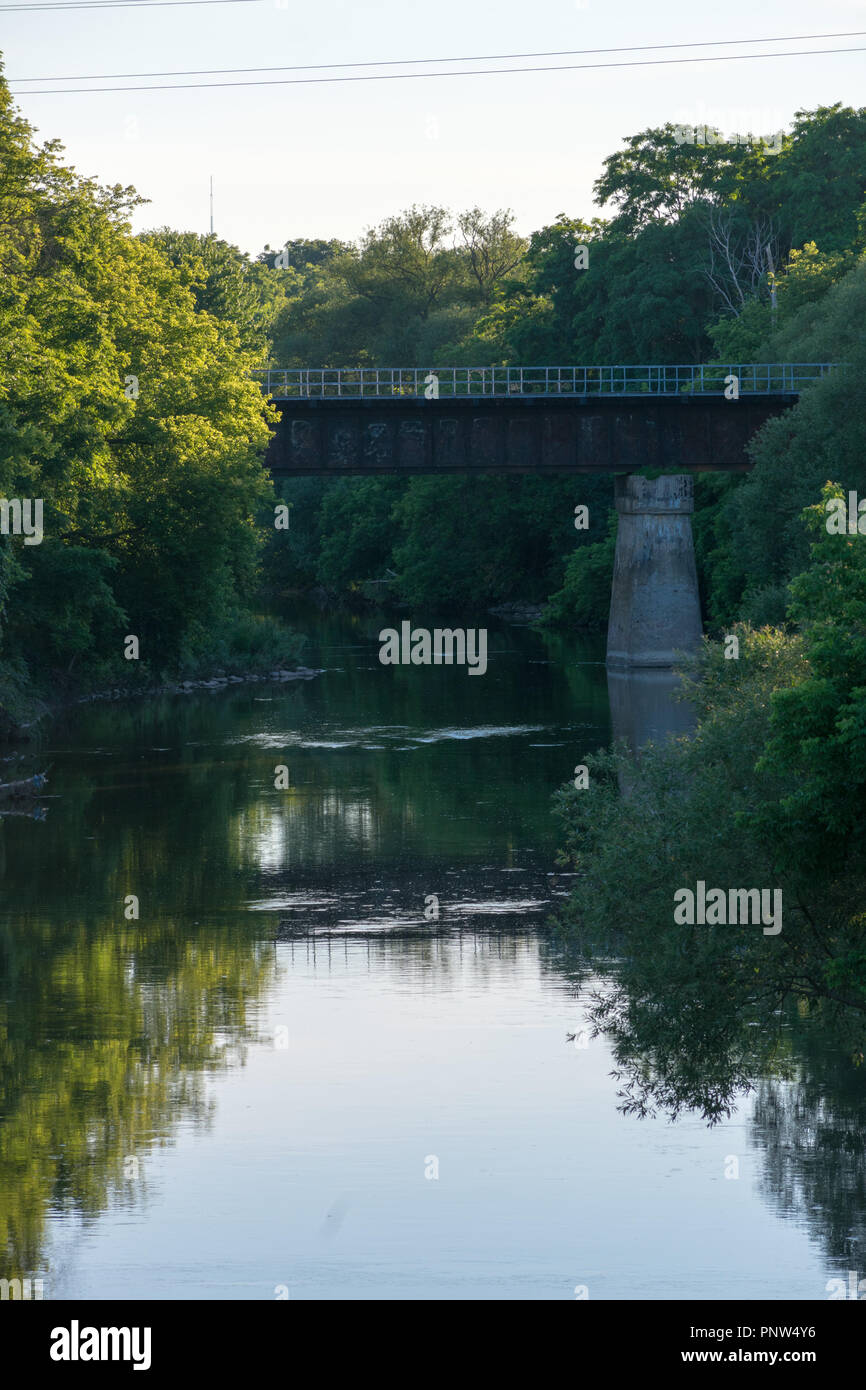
[{"x1": 0, "y1": 65, "x2": 308, "y2": 717}]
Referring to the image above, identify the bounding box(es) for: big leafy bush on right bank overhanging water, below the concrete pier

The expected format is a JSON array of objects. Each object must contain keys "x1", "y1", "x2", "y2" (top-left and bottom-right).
[{"x1": 557, "y1": 626, "x2": 866, "y2": 1120}]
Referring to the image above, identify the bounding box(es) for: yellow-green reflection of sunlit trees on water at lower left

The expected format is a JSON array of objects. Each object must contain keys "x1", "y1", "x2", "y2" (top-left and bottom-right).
[{"x1": 0, "y1": 913, "x2": 274, "y2": 1282}]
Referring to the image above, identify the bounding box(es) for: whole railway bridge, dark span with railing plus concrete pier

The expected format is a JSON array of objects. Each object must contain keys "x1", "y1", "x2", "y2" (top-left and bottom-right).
[{"x1": 256, "y1": 363, "x2": 837, "y2": 670}]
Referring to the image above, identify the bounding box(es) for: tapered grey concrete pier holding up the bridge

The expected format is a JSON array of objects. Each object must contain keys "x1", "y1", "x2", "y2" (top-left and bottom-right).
[{"x1": 607, "y1": 473, "x2": 701, "y2": 669}]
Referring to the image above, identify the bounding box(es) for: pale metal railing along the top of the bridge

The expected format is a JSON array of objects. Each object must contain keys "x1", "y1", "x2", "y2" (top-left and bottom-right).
[{"x1": 253, "y1": 361, "x2": 838, "y2": 400}]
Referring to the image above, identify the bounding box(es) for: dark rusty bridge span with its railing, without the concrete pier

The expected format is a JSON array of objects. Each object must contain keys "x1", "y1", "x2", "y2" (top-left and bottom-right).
[{"x1": 261, "y1": 363, "x2": 834, "y2": 477}]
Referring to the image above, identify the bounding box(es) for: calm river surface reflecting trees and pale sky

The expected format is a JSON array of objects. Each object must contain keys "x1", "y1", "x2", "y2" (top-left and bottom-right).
[{"x1": 0, "y1": 620, "x2": 865, "y2": 1300}]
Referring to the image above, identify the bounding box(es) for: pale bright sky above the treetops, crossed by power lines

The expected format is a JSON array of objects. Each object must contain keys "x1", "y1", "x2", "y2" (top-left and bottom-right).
[{"x1": 0, "y1": 0, "x2": 866, "y2": 253}]
